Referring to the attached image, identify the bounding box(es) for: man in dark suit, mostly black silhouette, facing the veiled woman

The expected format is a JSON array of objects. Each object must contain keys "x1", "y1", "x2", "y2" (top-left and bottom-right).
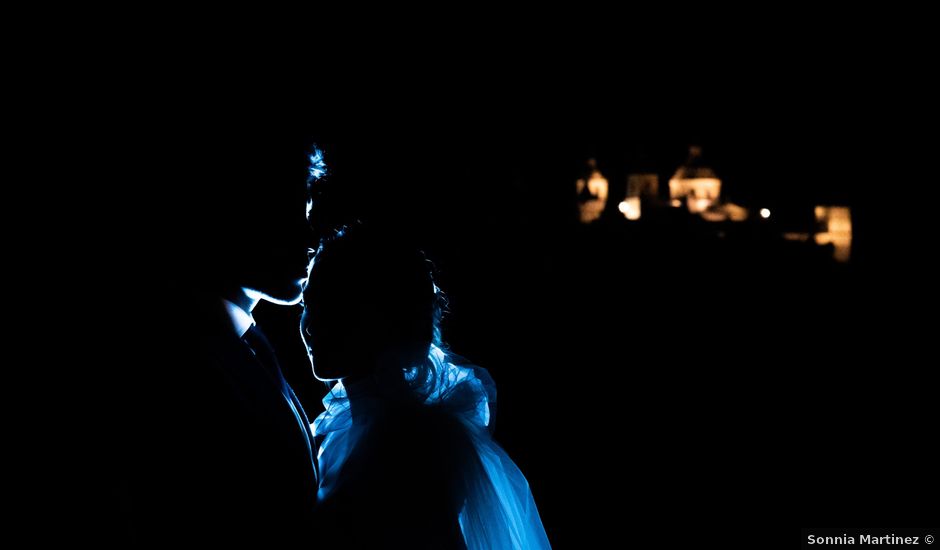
[{"x1": 125, "y1": 119, "x2": 317, "y2": 547}]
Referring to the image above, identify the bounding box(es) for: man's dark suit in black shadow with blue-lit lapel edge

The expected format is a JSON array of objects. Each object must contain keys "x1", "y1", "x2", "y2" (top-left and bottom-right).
[{"x1": 126, "y1": 300, "x2": 317, "y2": 546}]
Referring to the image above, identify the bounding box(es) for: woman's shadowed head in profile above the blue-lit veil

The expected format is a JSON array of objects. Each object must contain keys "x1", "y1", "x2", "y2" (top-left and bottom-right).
[{"x1": 301, "y1": 225, "x2": 443, "y2": 381}]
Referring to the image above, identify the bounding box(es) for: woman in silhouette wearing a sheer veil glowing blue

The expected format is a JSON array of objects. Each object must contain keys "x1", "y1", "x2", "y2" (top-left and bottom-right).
[{"x1": 301, "y1": 226, "x2": 550, "y2": 549}]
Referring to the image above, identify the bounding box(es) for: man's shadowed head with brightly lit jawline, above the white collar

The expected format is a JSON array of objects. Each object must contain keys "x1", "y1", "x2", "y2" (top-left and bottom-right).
[{"x1": 162, "y1": 103, "x2": 324, "y2": 305}]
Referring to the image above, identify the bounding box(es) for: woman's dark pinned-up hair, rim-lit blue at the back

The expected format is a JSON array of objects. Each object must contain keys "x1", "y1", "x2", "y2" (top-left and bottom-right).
[{"x1": 308, "y1": 224, "x2": 446, "y2": 380}]
